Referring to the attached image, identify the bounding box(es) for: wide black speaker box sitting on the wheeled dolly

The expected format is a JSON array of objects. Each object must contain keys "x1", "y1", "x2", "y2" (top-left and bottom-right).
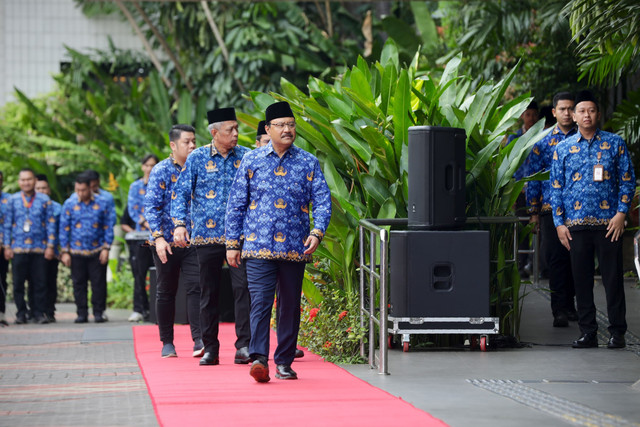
[{"x1": 389, "y1": 230, "x2": 489, "y2": 317}]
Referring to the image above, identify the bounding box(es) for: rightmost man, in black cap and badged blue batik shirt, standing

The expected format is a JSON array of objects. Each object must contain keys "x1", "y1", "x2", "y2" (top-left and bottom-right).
[{"x1": 551, "y1": 91, "x2": 636, "y2": 348}]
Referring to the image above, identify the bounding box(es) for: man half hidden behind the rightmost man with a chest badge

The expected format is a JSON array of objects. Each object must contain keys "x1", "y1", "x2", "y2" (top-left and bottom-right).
[{"x1": 526, "y1": 92, "x2": 578, "y2": 327}]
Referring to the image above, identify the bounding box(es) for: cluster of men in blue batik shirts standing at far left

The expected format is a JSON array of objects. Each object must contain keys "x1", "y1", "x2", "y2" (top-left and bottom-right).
[{"x1": 0, "y1": 168, "x2": 116, "y2": 325}]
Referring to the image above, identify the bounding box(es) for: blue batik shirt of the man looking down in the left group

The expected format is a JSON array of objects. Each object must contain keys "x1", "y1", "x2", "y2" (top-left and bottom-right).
[{"x1": 59, "y1": 193, "x2": 113, "y2": 256}]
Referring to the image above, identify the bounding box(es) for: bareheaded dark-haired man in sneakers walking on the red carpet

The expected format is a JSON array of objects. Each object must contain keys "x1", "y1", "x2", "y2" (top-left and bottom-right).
[{"x1": 144, "y1": 125, "x2": 204, "y2": 358}]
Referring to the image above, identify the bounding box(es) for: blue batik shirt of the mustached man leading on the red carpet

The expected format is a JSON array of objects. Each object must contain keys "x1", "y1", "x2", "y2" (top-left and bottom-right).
[{"x1": 226, "y1": 143, "x2": 331, "y2": 262}]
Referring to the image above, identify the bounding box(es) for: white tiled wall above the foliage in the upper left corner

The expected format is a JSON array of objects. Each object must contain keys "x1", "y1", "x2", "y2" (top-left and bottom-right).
[{"x1": 0, "y1": 0, "x2": 143, "y2": 105}]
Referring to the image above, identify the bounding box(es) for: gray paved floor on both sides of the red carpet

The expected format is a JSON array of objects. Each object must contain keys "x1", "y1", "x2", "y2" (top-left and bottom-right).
[{"x1": 0, "y1": 282, "x2": 640, "y2": 427}]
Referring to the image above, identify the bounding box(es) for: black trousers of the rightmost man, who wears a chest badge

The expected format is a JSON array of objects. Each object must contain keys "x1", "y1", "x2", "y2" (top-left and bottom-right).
[{"x1": 570, "y1": 230, "x2": 627, "y2": 335}]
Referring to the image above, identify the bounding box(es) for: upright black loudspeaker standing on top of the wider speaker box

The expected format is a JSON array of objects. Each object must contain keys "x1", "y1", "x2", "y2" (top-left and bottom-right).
[{"x1": 408, "y1": 126, "x2": 467, "y2": 230}]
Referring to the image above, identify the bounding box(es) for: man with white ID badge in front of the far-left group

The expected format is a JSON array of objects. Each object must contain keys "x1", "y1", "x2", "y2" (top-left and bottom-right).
[{"x1": 3, "y1": 169, "x2": 56, "y2": 324}]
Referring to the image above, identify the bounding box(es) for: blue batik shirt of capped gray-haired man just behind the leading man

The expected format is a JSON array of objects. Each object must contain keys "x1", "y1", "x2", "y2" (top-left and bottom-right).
[{"x1": 171, "y1": 143, "x2": 251, "y2": 246}]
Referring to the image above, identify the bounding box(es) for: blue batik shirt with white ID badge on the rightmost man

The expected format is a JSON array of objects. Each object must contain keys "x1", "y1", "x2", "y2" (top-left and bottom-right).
[{"x1": 550, "y1": 129, "x2": 636, "y2": 229}]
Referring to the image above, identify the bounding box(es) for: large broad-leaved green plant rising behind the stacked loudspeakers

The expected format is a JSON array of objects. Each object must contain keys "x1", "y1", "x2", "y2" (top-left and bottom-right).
[{"x1": 251, "y1": 41, "x2": 542, "y2": 334}]
